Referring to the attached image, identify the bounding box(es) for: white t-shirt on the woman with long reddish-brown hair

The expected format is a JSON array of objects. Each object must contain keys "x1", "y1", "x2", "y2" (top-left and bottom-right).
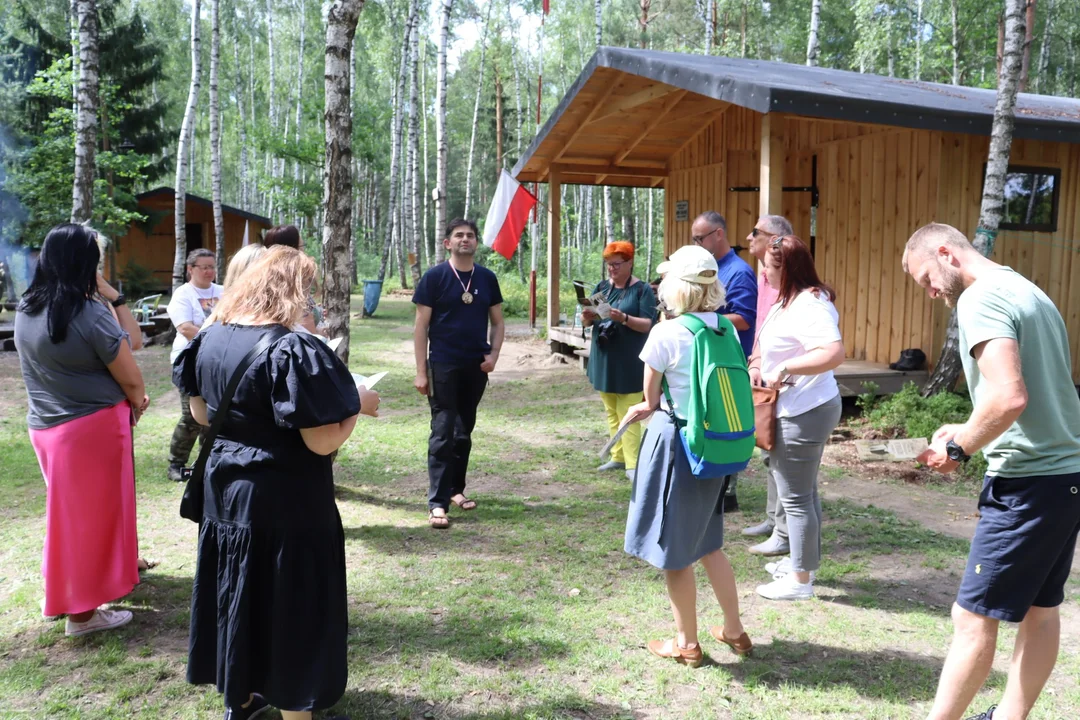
[{"x1": 758, "y1": 290, "x2": 841, "y2": 418}]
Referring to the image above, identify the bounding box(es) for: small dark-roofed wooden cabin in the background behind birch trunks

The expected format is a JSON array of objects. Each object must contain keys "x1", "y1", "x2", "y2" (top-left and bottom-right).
[{"x1": 106, "y1": 188, "x2": 273, "y2": 290}]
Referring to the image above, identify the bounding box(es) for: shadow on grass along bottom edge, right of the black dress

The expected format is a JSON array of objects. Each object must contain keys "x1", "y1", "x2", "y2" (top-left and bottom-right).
[{"x1": 334, "y1": 690, "x2": 646, "y2": 720}]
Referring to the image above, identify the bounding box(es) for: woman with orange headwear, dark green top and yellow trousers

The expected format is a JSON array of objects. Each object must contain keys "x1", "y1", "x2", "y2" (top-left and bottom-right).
[{"x1": 581, "y1": 242, "x2": 657, "y2": 477}]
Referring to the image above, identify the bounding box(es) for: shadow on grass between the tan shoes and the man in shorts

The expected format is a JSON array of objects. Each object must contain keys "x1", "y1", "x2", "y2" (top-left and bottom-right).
[{"x1": 725, "y1": 638, "x2": 1004, "y2": 702}]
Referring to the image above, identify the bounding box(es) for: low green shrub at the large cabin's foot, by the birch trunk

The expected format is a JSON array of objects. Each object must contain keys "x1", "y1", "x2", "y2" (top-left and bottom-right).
[{"x1": 867, "y1": 382, "x2": 986, "y2": 478}]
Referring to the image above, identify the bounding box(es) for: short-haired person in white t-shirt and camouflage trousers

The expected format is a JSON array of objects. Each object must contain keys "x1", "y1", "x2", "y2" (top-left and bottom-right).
[{"x1": 166, "y1": 248, "x2": 221, "y2": 483}]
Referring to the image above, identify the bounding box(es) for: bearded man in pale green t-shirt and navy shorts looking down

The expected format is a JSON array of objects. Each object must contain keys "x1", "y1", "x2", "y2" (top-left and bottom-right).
[{"x1": 903, "y1": 223, "x2": 1080, "y2": 720}]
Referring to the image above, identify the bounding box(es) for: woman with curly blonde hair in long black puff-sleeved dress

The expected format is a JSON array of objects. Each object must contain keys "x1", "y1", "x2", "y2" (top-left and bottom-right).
[{"x1": 173, "y1": 247, "x2": 379, "y2": 720}]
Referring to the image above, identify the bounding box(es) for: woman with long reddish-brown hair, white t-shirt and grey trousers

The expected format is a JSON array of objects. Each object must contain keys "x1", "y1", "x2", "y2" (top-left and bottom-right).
[{"x1": 750, "y1": 235, "x2": 843, "y2": 600}]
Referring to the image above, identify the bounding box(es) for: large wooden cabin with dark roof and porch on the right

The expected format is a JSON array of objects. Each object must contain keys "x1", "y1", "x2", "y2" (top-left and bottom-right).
[{"x1": 513, "y1": 47, "x2": 1080, "y2": 384}]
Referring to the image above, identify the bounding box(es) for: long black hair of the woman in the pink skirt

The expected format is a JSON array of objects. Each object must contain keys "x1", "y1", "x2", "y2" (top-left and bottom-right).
[{"x1": 18, "y1": 222, "x2": 102, "y2": 342}]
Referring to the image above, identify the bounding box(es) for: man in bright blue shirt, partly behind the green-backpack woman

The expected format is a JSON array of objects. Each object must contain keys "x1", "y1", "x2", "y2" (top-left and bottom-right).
[{"x1": 690, "y1": 210, "x2": 757, "y2": 513}]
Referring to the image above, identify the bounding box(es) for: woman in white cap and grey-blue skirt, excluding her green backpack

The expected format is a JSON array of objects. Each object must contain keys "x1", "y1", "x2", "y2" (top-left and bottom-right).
[{"x1": 623, "y1": 245, "x2": 753, "y2": 667}]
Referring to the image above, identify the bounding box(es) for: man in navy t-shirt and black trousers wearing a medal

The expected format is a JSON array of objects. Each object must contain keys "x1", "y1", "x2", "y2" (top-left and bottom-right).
[{"x1": 413, "y1": 219, "x2": 504, "y2": 529}]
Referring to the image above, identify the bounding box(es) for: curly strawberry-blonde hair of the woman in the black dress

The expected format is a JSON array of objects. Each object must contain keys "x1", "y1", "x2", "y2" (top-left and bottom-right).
[{"x1": 214, "y1": 245, "x2": 315, "y2": 327}]
